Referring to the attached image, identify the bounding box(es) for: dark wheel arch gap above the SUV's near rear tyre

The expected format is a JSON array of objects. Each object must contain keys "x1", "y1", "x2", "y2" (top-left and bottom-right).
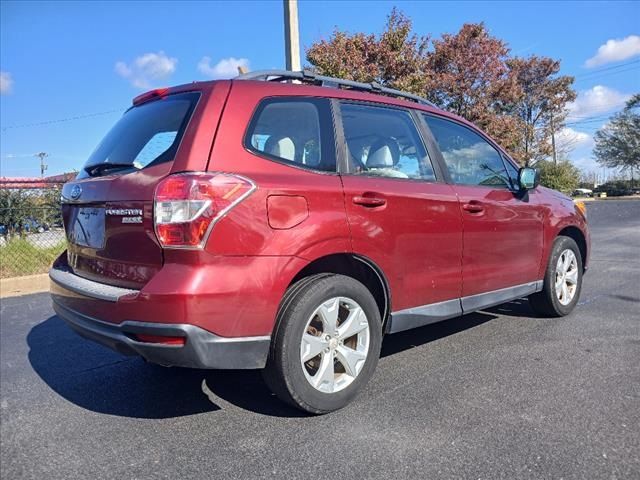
[{"x1": 289, "y1": 253, "x2": 391, "y2": 332}]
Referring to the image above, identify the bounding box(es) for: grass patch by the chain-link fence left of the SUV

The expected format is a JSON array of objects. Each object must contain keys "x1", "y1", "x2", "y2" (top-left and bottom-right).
[{"x1": 0, "y1": 238, "x2": 66, "y2": 278}]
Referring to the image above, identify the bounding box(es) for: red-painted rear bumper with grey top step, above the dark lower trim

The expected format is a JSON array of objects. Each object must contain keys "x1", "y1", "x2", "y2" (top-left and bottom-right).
[{"x1": 49, "y1": 251, "x2": 308, "y2": 338}]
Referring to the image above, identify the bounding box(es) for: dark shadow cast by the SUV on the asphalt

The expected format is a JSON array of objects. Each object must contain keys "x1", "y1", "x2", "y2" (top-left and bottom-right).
[{"x1": 27, "y1": 304, "x2": 524, "y2": 418}]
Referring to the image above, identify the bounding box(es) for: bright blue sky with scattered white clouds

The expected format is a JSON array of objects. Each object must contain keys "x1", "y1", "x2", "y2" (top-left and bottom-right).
[{"x1": 0, "y1": 0, "x2": 640, "y2": 176}]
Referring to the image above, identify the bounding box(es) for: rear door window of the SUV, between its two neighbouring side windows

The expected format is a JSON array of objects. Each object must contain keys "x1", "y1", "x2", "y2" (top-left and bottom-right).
[{"x1": 340, "y1": 103, "x2": 436, "y2": 181}]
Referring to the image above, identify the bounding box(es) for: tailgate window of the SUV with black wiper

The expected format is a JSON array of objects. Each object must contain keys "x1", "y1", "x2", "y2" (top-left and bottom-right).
[{"x1": 81, "y1": 92, "x2": 200, "y2": 176}]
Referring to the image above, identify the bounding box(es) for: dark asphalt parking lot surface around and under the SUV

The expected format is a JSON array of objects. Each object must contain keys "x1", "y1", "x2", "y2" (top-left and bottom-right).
[{"x1": 0, "y1": 200, "x2": 640, "y2": 479}]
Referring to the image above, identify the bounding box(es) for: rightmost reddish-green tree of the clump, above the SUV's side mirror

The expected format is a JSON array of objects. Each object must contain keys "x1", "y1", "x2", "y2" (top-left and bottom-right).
[{"x1": 507, "y1": 55, "x2": 576, "y2": 165}]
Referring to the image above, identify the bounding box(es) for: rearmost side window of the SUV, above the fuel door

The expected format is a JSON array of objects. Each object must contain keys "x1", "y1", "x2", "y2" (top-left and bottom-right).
[{"x1": 245, "y1": 98, "x2": 336, "y2": 172}]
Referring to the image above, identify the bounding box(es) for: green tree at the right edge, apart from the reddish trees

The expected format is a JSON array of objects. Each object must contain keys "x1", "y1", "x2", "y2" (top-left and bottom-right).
[{"x1": 593, "y1": 93, "x2": 640, "y2": 188}]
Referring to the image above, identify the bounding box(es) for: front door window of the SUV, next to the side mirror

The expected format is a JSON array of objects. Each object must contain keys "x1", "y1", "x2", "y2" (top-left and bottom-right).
[{"x1": 425, "y1": 115, "x2": 510, "y2": 188}]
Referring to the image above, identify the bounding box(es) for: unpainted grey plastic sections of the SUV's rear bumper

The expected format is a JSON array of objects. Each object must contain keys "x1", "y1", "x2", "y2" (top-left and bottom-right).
[{"x1": 50, "y1": 270, "x2": 270, "y2": 369}]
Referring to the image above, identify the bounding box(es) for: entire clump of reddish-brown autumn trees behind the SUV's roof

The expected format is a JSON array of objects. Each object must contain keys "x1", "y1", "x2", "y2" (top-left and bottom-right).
[{"x1": 307, "y1": 8, "x2": 575, "y2": 164}]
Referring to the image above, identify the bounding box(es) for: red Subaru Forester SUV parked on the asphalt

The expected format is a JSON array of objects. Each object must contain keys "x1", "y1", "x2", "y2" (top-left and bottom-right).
[{"x1": 50, "y1": 71, "x2": 590, "y2": 413}]
